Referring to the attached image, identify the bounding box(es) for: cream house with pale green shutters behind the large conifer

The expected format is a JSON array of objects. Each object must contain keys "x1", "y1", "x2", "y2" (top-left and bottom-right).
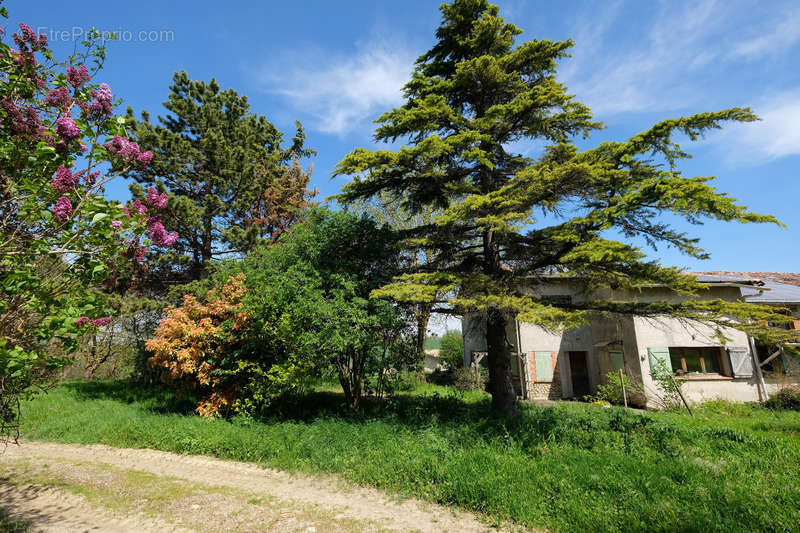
[{"x1": 462, "y1": 273, "x2": 800, "y2": 406}]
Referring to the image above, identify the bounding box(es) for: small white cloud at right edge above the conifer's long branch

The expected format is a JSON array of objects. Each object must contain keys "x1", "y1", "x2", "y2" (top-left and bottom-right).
[{"x1": 709, "y1": 88, "x2": 800, "y2": 164}]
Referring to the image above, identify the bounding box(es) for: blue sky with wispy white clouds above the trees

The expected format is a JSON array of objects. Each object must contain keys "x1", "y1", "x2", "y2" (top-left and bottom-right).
[{"x1": 6, "y1": 0, "x2": 800, "y2": 271}]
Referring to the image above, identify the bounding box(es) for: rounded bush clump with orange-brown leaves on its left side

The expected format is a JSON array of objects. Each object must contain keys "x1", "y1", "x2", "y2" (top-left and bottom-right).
[{"x1": 148, "y1": 209, "x2": 417, "y2": 416}]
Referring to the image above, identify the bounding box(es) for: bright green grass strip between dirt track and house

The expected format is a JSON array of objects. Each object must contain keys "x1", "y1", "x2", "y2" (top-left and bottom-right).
[{"x1": 15, "y1": 382, "x2": 800, "y2": 531}]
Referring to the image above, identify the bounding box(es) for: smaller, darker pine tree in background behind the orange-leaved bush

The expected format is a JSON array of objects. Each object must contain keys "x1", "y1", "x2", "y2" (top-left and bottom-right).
[{"x1": 123, "y1": 72, "x2": 316, "y2": 280}]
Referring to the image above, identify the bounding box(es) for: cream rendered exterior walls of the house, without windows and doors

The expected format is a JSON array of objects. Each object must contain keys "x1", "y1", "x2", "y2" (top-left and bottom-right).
[{"x1": 462, "y1": 279, "x2": 800, "y2": 406}]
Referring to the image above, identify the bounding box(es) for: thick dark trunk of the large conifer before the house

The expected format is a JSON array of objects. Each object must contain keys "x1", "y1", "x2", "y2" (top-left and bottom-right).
[{"x1": 486, "y1": 308, "x2": 517, "y2": 416}]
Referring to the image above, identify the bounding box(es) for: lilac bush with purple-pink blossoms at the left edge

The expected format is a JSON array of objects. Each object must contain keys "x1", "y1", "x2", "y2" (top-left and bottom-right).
[{"x1": 0, "y1": 10, "x2": 155, "y2": 440}]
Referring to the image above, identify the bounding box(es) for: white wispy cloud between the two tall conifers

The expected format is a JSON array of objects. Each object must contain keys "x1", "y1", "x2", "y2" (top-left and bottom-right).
[{"x1": 253, "y1": 37, "x2": 416, "y2": 135}]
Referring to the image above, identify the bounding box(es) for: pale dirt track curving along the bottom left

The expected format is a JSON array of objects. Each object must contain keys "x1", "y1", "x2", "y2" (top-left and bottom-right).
[{"x1": 0, "y1": 442, "x2": 524, "y2": 533}]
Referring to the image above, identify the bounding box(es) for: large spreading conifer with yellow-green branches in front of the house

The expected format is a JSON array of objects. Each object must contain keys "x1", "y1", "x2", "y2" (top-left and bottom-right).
[{"x1": 335, "y1": 0, "x2": 778, "y2": 414}]
